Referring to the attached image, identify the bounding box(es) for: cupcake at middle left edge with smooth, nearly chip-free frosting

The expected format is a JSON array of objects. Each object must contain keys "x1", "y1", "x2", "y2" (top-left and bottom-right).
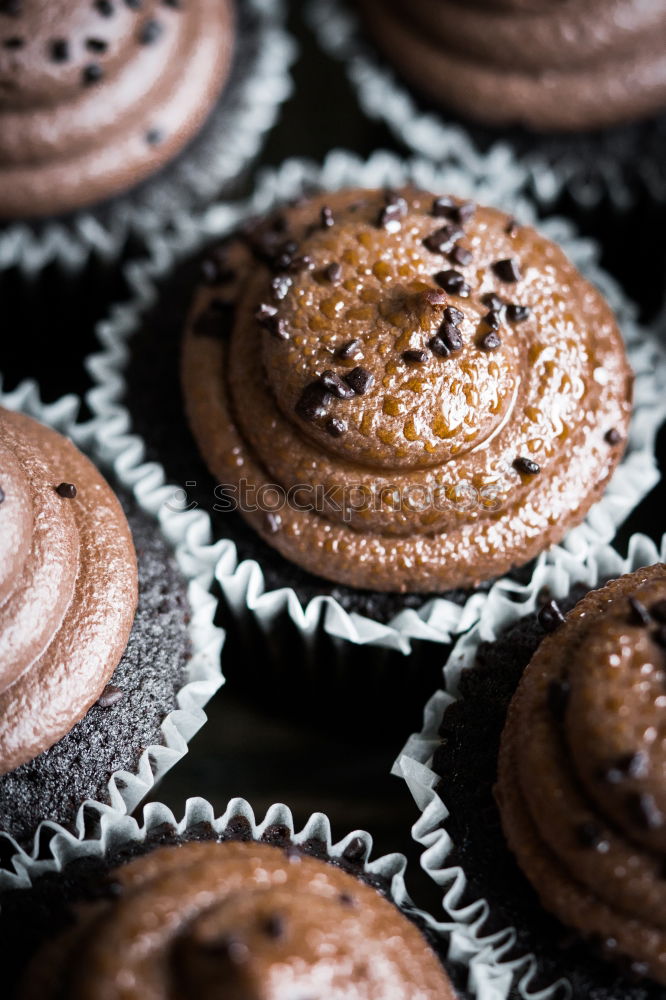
[{"x1": 0, "y1": 400, "x2": 221, "y2": 845}]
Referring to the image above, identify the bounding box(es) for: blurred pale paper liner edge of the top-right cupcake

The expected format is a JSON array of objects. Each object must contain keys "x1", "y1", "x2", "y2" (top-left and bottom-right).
[{"x1": 307, "y1": 0, "x2": 666, "y2": 210}]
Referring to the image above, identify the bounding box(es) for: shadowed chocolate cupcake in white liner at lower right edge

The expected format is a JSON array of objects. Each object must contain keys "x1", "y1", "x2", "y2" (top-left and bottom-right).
[{"x1": 394, "y1": 537, "x2": 666, "y2": 1000}]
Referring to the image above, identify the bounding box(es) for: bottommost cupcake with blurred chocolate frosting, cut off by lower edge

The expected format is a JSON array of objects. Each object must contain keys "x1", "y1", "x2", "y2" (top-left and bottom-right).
[{"x1": 0, "y1": 800, "x2": 455, "y2": 1000}]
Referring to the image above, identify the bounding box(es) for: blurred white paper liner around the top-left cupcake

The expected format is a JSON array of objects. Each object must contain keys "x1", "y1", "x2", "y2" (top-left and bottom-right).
[{"x1": 0, "y1": 0, "x2": 296, "y2": 277}]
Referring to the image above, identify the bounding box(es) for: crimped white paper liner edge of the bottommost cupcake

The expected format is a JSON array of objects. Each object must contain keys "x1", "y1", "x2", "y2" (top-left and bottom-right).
[{"x1": 0, "y1": 798, "x2": 509, "y2": 1000}]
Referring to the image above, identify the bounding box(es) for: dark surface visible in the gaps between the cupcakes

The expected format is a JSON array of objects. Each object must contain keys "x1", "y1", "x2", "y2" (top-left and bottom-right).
[{"x1": 0, "y1": 3, "x2": 666, "y2": 912}]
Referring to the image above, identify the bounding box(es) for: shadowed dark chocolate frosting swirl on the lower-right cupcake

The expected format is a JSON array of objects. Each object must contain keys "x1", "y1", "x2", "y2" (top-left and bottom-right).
[{"x1": 497, "y1": 565, "x2": 666, "y2": 983}]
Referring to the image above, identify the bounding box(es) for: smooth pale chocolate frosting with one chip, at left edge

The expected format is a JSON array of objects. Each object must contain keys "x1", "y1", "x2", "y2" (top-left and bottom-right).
[{"x1": 0, "y1": 409, "x2": 137, "y2": 774}]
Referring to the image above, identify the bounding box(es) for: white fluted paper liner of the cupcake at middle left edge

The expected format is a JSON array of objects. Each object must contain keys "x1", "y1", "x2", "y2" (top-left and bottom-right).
[{"x1": 0, "y1": 378, "x2": 224, "y2": 860}]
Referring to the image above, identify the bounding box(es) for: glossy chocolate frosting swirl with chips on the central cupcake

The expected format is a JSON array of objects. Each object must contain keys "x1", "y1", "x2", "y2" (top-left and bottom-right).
[{"x1": 183, "y1": 190, "x2": 632, "y2": 592}]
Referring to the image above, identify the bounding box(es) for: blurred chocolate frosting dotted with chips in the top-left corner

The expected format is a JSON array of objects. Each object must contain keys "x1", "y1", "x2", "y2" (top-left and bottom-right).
[{"x1": 0, "y1": 0, "x2": 233, "y2": 219}]
